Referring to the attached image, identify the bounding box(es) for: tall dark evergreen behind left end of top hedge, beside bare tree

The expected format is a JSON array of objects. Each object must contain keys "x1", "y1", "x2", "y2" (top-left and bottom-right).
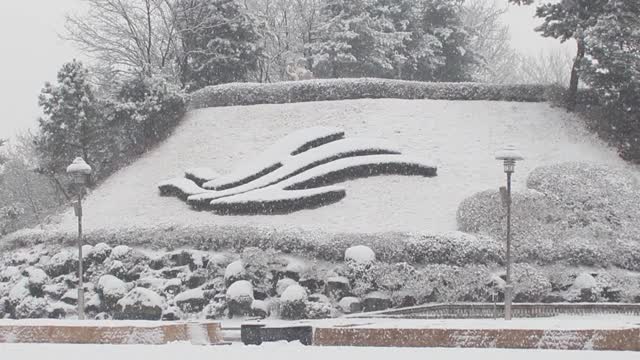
[{"x1": 175, "y1": 0, "x2": 262, "y2": 90}]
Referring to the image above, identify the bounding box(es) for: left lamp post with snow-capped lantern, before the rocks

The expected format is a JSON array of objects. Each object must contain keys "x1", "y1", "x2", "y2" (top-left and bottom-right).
[{"x1": 67, "y1": 157, "x2": 91, "y2": 320}]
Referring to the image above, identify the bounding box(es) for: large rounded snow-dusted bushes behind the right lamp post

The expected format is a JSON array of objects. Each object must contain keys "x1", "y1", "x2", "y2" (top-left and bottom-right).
[{"x1": 458, "y1": 163, "x2": 640, "y2": 270}]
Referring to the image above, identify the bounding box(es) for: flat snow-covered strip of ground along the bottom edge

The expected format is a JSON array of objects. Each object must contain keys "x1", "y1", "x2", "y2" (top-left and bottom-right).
[{"x1": 0, "y1": 343, "x2": 638, "y2": 360}]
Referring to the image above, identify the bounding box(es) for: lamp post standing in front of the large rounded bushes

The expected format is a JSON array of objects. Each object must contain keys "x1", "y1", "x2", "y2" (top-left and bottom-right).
[{"x1": 496, "y1": 145, "x2": 524, "y2": 320}]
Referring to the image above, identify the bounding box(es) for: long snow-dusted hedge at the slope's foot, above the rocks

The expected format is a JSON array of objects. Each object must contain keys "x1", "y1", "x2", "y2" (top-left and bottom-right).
[{"x1": 0, "y1": 224, "x2": 640, "y2": 271}]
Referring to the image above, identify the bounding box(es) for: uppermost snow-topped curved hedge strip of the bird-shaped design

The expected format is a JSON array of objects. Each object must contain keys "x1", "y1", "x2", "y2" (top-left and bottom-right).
[{"x1": 203, "y1": 127, "x2": 344, "y2": 190}]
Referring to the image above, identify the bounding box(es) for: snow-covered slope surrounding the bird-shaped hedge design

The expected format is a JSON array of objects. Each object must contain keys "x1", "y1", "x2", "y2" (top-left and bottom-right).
[{"x1": 52, "y1": 99, "x2": 627, "y2": 232}]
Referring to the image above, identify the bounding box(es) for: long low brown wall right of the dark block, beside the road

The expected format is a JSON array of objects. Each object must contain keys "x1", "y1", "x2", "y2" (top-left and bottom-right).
[{"x1": 313, "y1": 328, "x2": 640, "y2": 351}]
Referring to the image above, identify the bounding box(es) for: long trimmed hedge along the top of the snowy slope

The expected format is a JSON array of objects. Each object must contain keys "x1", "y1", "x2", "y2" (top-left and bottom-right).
[{"x1": 190, "y1": 78, "x2": 550, "y2": 109}]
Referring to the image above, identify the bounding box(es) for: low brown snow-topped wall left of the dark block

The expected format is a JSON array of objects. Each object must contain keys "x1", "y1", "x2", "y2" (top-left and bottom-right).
[{"x1": 0, "y1": 321, "x2": 223, "y2": 345}]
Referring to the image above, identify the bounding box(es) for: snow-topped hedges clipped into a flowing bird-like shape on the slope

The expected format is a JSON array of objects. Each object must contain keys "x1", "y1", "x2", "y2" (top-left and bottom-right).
[{"x1": 158, "y1": 127, "x2": 437, "y2": 215}]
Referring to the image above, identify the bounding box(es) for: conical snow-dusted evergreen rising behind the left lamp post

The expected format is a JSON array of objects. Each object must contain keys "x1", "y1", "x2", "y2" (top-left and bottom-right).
[{"x1": 37, "y1": 60, "x2": 100, "y2": 177}]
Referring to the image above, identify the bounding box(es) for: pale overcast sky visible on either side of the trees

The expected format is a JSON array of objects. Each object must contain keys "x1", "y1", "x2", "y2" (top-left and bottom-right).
[{"x1": 0, "y1": 0, "x2": 559, "y2": 138}]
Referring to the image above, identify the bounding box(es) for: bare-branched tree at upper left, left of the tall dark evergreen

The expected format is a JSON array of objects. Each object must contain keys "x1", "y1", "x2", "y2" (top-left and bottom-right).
[{"x1": 66, "y1": 0, "x2": 178, "y2": 81}]
